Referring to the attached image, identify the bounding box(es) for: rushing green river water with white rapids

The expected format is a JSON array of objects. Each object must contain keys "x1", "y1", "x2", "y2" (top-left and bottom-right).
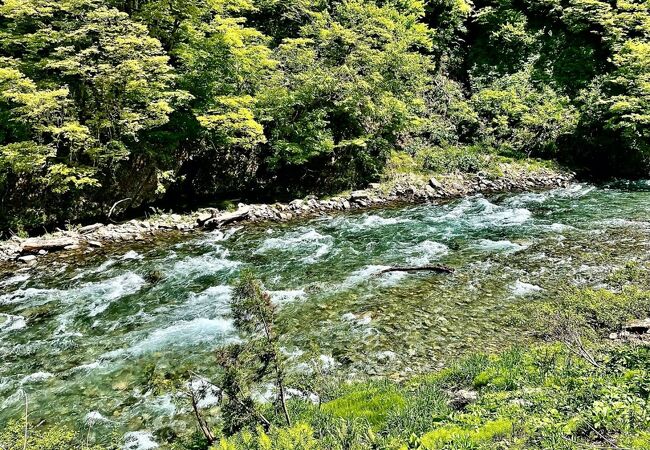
[{"x1": 0, "y1": 182, "x2": 650, "y2": 448}]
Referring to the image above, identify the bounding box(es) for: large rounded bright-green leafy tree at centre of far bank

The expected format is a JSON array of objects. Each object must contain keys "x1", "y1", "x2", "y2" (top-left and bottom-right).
[{"x1": 258, "y1": 0, "x2": 432, "y2": 192}]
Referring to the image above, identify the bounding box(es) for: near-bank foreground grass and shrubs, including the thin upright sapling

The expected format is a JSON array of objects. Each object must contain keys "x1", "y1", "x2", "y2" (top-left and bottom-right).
[{"x1": 0, "y1": 264, "x2": 650, "y2": 450}]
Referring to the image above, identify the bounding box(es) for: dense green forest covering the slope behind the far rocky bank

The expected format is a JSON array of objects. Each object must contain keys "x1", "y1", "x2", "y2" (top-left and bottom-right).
[{"x1": 0, "y1": 0, "x2": 650, "y2": 231}]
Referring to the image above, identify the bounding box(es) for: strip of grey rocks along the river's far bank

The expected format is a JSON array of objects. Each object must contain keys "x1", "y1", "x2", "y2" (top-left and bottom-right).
[{"x1": 0, "y1": 165, "x2": 574, "y2": 265}]
